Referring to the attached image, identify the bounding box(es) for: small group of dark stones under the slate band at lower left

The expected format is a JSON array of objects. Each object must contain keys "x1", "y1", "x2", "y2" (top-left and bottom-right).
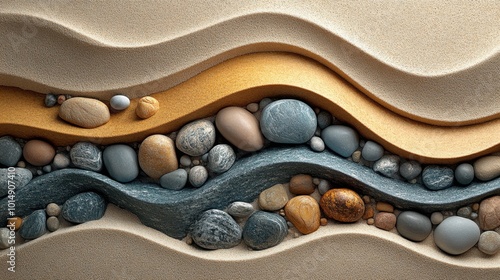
[{"x1": 0, "y1": 192, "x2": 106, "y2": 249}]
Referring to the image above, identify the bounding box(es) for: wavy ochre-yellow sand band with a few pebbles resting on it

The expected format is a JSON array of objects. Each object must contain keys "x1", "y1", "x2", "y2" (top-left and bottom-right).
[{"x1": 0, "y1": 53, "x2": 500, "y2": 164}]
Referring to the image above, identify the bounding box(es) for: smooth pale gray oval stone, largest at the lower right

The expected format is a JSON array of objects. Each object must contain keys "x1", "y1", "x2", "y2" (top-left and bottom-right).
[{"x1": 434, "y1": 216, "x2": 481, "y2": 255}]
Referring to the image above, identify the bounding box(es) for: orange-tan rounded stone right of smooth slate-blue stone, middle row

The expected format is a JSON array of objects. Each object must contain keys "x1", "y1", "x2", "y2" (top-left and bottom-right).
[{"x1": 138, "y1": 134, "x2": 179, "y2": 179}]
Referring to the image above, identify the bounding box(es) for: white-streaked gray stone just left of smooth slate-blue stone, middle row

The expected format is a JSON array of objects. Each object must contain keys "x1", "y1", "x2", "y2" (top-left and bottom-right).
[{"x1": 69, "y1": 142, "x2": 102, "y2": 172}]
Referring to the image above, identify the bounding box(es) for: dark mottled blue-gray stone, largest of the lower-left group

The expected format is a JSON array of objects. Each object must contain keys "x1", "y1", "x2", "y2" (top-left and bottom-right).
[{"x1": 62, "y1": 192, "x2": 106, "y2": 224}]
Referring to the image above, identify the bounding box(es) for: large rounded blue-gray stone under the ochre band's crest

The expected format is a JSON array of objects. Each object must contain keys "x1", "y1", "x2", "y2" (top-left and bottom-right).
[{"x1": 260, "y1": 99, "x2": 317, "y2": 144}]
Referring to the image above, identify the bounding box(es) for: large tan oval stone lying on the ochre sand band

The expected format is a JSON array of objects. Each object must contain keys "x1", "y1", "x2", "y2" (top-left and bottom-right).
[{"x1": 59, "y1": 97, "x2": 110, "y2": 128}]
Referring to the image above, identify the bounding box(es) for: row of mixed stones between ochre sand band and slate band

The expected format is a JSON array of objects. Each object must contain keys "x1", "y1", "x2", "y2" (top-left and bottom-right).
[{"x1": 0, "y1": 98, "x2": 500, "y2": 194}]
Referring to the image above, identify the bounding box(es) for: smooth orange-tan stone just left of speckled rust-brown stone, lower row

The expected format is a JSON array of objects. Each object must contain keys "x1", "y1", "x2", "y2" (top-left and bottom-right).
[{"x1": 285, "y1": 195, "x2": 321, "y2": 234}]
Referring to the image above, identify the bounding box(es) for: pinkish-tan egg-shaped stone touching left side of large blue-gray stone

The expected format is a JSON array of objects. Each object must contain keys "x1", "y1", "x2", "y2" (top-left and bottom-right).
[{"x1": 215, "y1": 106, "x2": 264, "y2": 152}]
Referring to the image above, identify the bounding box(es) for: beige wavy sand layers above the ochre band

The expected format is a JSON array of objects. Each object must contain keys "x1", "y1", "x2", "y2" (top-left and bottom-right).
[{"x1": 0, "y1": 0, "x2": 500, "y2": 125}]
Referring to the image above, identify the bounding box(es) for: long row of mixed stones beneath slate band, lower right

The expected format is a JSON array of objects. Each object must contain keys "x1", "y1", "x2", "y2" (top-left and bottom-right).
[{"x1": 186, "y1": 174, "x2": 500, "y2": 255}]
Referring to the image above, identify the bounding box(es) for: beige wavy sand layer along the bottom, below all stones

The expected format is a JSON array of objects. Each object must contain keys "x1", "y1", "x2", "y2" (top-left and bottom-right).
[{"x1": 0, "y1": 204, "x2": 500, "y2": 279}]
